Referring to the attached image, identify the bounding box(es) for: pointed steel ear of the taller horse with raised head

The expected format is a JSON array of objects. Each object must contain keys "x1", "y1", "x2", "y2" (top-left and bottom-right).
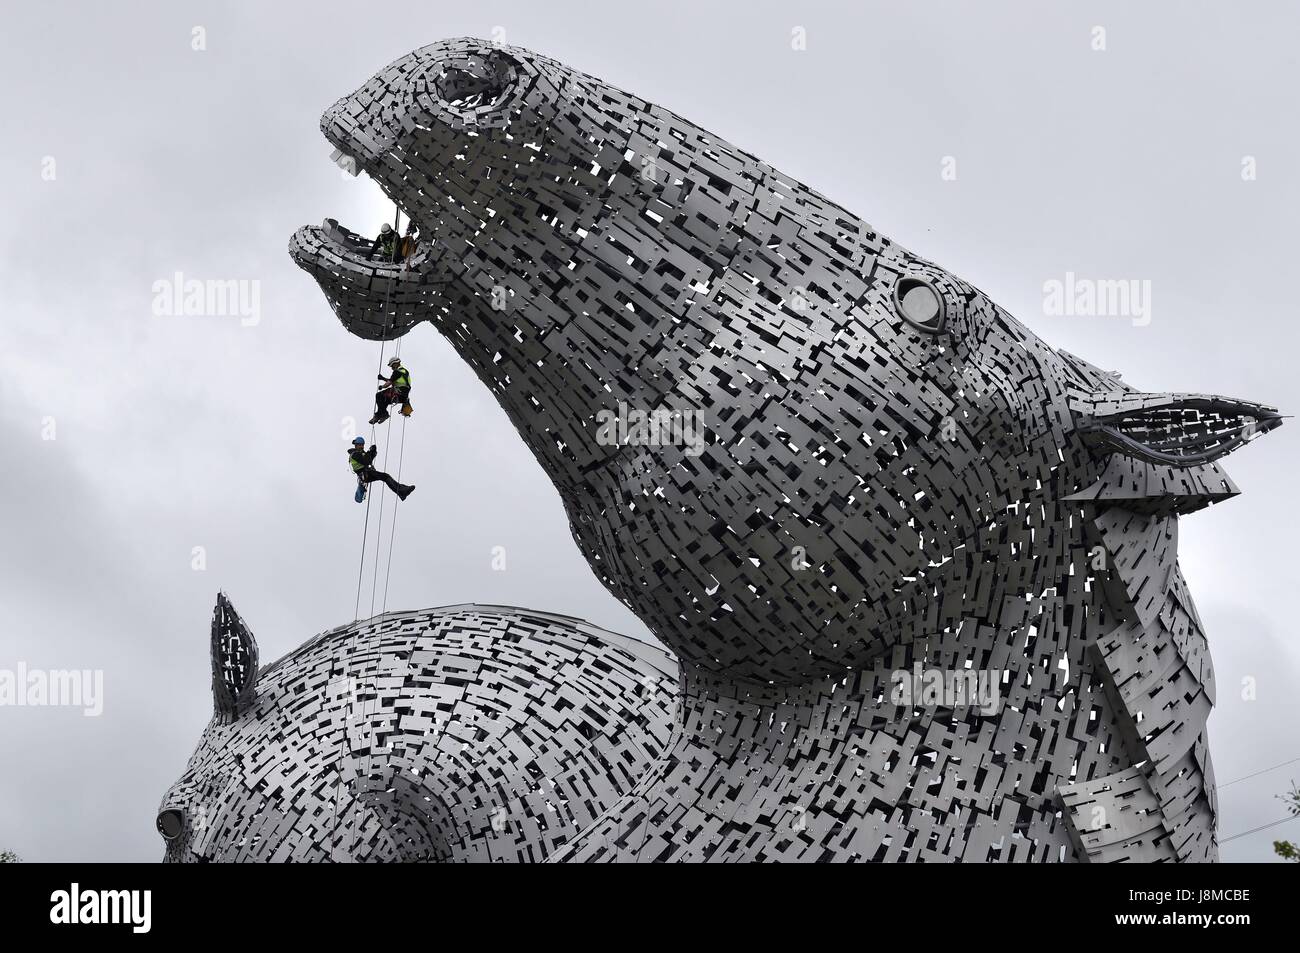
[{"x1": 1071, "y1": 391, "x2": 1282, "y2": 468}]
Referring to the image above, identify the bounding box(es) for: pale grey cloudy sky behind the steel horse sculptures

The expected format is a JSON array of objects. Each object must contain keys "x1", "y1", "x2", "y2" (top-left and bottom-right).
[{"x1": 0, "y1": 0, "x2": 1300, "y2": 861}]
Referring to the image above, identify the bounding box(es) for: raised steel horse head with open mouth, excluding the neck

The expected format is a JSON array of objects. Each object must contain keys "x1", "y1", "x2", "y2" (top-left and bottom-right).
[{"x1": 291, "y1": 39, "x2": 1279, "y2": 684}]
